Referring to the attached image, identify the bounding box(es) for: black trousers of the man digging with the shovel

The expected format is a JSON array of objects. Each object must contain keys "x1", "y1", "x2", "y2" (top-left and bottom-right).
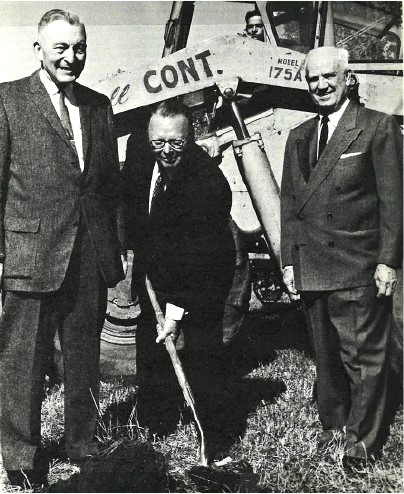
[{"x1": 136, "y1": 278, "x2": 229, "y2": 450}]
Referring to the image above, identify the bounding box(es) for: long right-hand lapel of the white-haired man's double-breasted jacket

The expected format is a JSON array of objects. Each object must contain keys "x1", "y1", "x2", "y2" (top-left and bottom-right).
[{"x1": 297, "y1": 103, "x2": 362, "y2": 211}]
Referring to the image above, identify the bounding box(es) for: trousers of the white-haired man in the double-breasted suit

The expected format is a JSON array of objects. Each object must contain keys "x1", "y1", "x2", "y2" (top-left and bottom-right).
[{"x1": 303, "y1": 286, "x2": 391, "y2": 458}]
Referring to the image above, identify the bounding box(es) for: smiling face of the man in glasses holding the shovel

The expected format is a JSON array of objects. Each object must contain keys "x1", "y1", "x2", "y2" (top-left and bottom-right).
[{"x1": 149, "y1": 113, "x2": 190, "y2": 173}]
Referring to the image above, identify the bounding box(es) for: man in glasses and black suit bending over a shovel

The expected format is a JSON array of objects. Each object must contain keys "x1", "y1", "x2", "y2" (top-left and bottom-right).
[{"x1": 123, "y1": 100, "x2": 235, "y2": 464}]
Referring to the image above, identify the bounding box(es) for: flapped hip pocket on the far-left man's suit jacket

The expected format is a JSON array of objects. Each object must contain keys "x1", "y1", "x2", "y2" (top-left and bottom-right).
[{"x1": 4, "y1": 218, "x2": 41, "y2": 278}]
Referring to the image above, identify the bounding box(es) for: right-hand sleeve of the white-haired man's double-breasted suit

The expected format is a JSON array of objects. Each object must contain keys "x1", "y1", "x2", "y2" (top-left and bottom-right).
[{"x1": 371, "y1": 115, "x2": 403, "y2": 267}]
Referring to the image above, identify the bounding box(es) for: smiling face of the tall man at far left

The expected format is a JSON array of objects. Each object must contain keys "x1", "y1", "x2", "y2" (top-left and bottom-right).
[{"x1": 35, "y1": 19, "x2": 87, "y2": 86}]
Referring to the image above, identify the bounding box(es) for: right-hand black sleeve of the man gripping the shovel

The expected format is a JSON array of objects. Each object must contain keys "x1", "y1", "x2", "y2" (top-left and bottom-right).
[{"x1": 155, "y1": 162, "x2": 235, "y2": 310}]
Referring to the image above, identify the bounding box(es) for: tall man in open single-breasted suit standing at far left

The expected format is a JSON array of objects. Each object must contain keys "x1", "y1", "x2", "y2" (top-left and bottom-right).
[{"x1": 0, "y1": 10, "x2": 124, "y2": 486}]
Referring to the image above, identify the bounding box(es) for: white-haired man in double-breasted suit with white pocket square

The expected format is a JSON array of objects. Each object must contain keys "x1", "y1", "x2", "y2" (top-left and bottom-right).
[{"x1": 281, "y1": 47, "x2": 402, "y2": 469}]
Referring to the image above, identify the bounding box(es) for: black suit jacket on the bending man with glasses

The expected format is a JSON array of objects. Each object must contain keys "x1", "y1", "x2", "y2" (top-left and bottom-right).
[{"x1": 124, "y1": 135, "x2": 235, "y2": 311}]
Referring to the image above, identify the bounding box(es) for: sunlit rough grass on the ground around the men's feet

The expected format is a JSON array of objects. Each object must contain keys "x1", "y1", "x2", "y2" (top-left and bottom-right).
[{"x1": 0, "y1": 306, "x2": 403, "y2": 492}]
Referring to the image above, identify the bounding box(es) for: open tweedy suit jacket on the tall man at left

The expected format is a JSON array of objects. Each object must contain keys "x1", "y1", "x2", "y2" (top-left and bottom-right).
[{"x1": 0, "y1": 71, "x2": 123, "y2": 292}]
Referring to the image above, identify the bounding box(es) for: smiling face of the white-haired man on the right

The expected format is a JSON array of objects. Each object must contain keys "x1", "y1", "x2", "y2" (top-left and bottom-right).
[{"x1": 306, "y1": 49, "x2": 350, "y2": 115}]
